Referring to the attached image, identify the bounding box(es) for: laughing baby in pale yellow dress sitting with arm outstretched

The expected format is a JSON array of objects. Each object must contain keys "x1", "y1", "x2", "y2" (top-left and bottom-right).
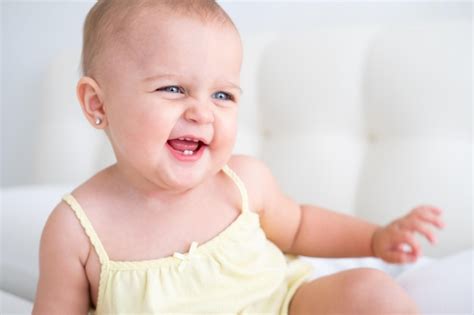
[{"x1": 33, "y1": 0, "x2": 443, "y2": 315}]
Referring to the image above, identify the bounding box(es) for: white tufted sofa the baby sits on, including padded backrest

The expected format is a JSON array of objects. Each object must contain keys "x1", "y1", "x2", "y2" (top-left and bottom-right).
[{"x1": 1, "y1": 22, "x2": 473, "y2": 314}]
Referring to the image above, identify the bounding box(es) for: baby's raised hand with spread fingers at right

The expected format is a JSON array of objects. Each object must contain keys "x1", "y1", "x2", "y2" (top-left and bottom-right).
[{"x1": 372, "y1": 206, "x2": 444, "y2": 263}]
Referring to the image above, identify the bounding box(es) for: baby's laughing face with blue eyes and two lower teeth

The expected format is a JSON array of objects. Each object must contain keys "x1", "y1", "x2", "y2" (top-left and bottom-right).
[{"x1": 98, "y1": 13, "x2": 242, "y2": 190}]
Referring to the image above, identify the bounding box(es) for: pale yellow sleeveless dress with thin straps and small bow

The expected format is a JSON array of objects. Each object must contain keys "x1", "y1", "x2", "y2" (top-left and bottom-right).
[{"x1": 63, "y1": 166, "x2": 311, "y2": 315}]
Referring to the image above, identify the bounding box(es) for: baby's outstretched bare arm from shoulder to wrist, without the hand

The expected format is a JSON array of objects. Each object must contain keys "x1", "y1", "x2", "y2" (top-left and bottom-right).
[{"x1": 230, "y1": 156, "x2": 377, "y2": 257}]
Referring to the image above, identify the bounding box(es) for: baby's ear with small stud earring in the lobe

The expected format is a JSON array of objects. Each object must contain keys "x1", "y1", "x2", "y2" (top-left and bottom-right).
[{"x1": 76, "y1": 76, "x2": 107, "y2": 129}]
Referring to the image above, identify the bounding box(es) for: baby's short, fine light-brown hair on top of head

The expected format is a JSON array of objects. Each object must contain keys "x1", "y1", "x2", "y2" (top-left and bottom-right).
[{"x1": 81, "y1": 0, "x2": 236, "y2": 76}]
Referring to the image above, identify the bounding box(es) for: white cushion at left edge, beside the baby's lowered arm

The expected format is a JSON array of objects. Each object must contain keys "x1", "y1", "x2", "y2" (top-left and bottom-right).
[{"x1": 0, "y1": 186, "x2": 71, "y2": 301}]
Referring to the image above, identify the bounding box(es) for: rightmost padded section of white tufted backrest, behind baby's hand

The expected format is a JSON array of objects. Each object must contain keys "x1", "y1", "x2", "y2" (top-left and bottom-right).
[{"x1": 355, "y1": 22, "x2": 474, "y2": 256}]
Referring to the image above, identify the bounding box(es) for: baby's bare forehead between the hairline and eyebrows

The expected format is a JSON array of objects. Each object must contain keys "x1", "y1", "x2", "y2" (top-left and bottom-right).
[{"x1": 105, "y1": 10, "x2": 242, "y2": 81}]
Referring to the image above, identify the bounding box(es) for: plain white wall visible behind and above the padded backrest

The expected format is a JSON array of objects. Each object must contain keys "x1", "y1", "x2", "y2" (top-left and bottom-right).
[{"x1": 1, "y1": 0, "x2": 472, "y2": 186}]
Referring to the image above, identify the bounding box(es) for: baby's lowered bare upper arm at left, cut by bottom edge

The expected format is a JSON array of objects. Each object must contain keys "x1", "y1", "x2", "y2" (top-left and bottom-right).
[{"x1": 33, "y1": 203, "x2": 89, "y2": 315}]
